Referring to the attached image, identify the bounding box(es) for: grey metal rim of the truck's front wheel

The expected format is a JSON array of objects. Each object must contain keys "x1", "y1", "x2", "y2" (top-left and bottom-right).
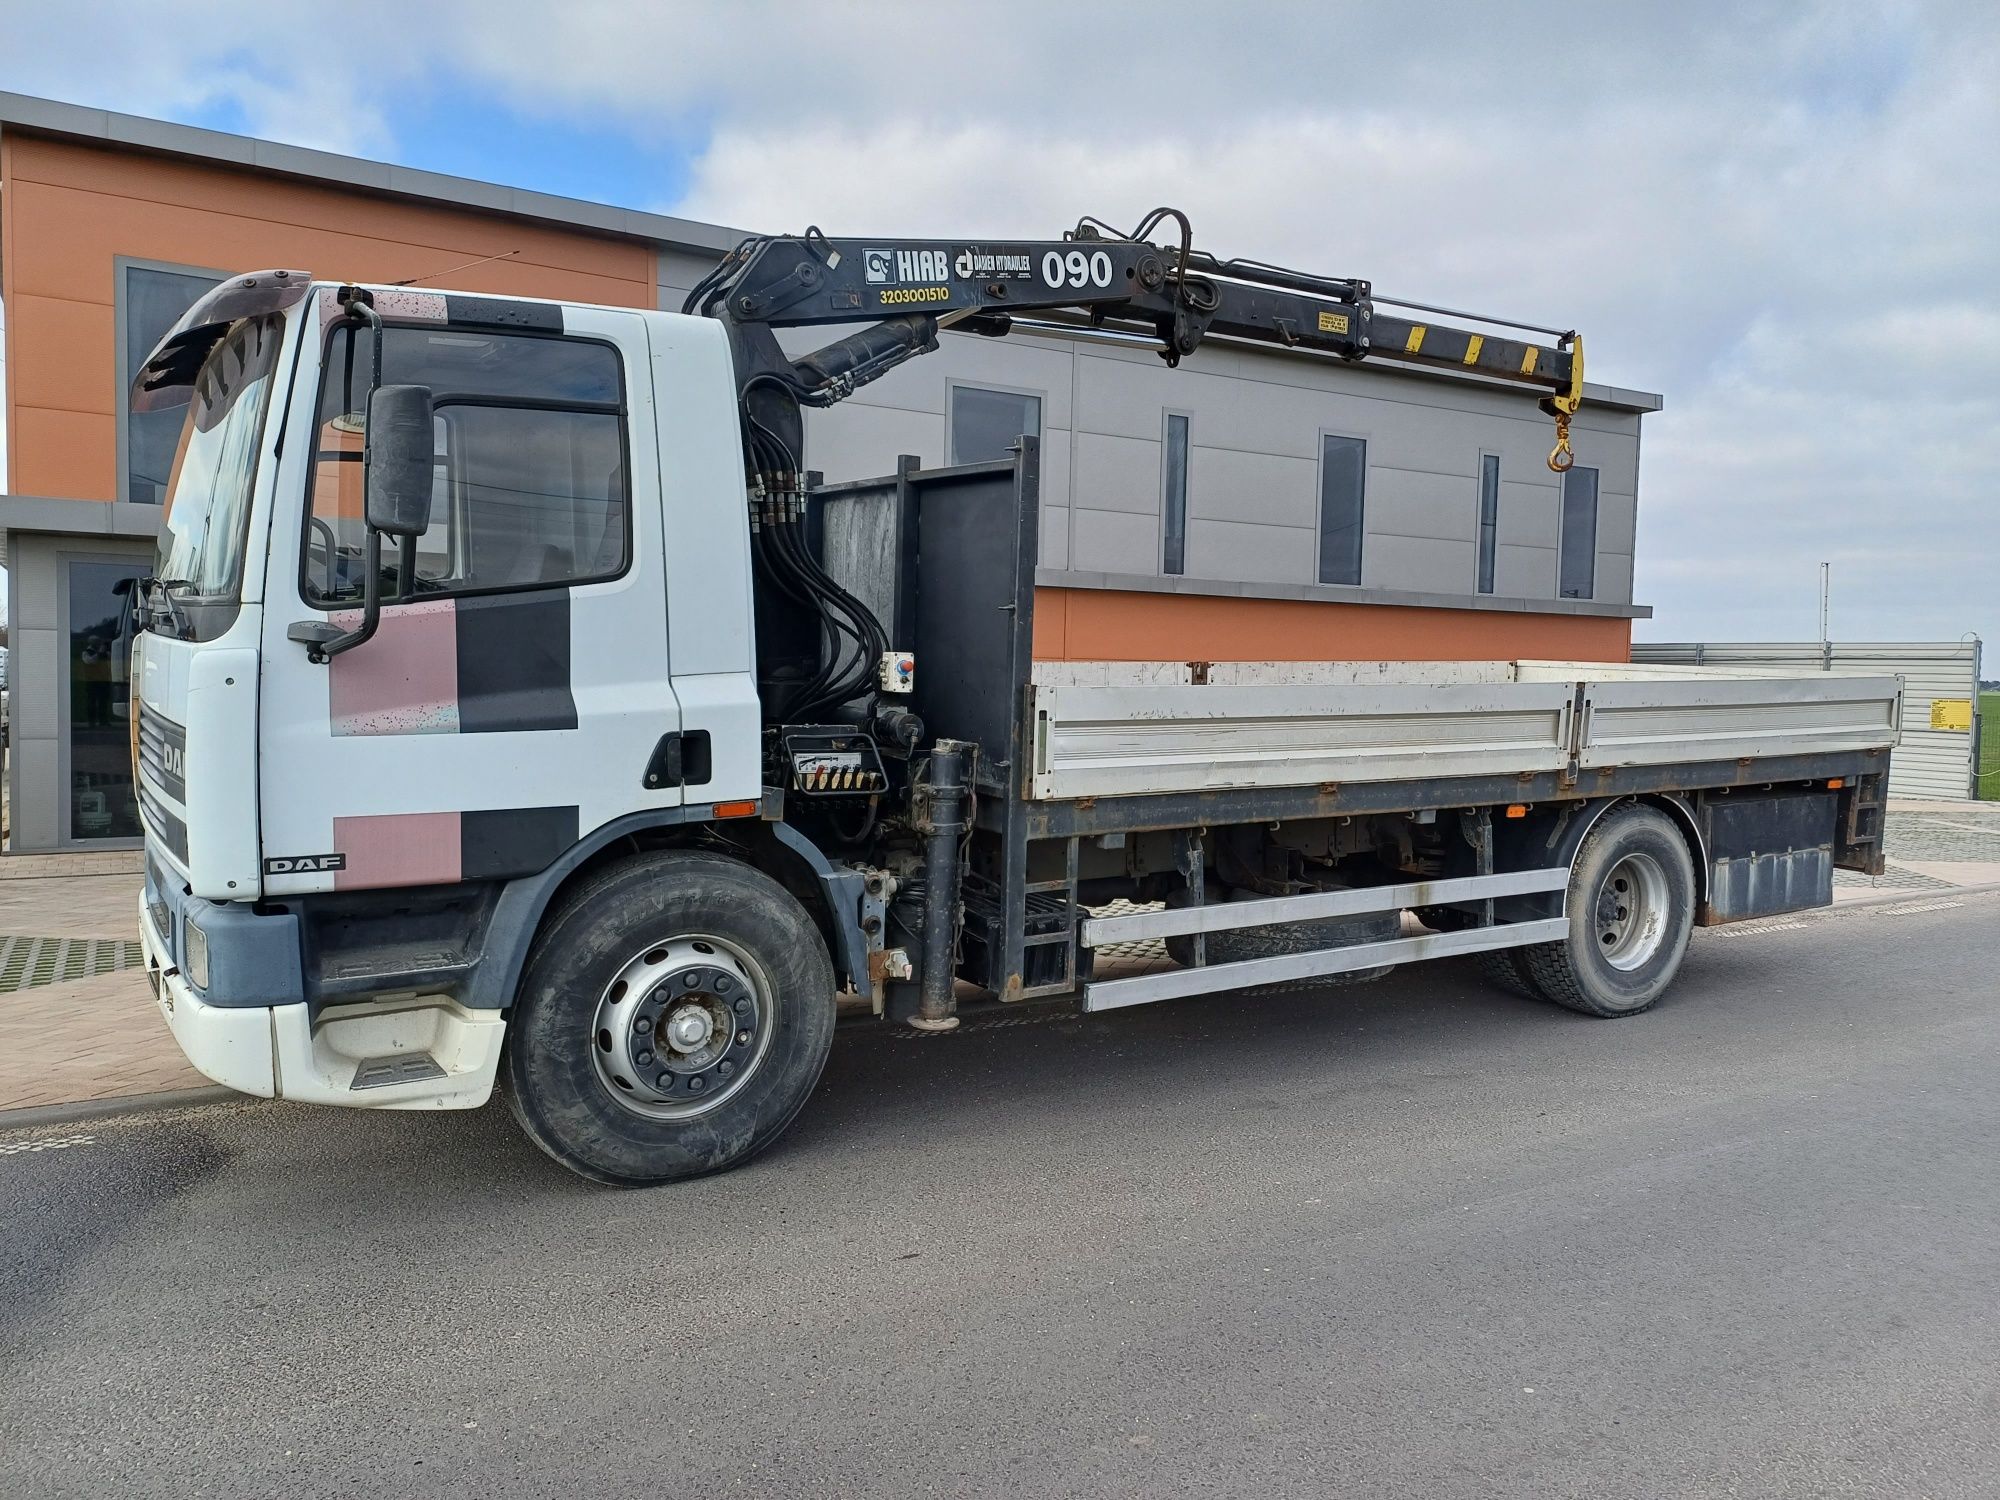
[{"x1": 590, "y1": 934, "x2": 776, "y2": 1120}]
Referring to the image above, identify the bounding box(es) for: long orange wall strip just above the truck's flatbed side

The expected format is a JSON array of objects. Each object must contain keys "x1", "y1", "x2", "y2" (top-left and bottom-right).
[{"x1": 1034, "y1": 588, "x2": 1632, "y2": 662}]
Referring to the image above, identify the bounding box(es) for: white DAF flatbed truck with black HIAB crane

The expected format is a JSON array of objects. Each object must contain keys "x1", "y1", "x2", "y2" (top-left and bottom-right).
[{"x1": 130, "y1": 220, "x2": 1898, "y2": 1186}]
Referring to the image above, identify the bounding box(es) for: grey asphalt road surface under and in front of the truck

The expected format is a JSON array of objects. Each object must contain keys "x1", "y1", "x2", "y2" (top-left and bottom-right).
[{"x1": 0, "y1": 894, "x2": 2000, "y2": 1500}]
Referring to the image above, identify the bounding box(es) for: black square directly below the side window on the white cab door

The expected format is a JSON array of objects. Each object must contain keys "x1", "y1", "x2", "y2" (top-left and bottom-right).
[{"x1": 456, "y1": 590, "x2": 576, "y2": 740}]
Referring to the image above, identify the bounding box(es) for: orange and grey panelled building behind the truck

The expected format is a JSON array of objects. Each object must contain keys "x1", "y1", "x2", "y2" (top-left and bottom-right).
[{"x1": 0, "y1": 94, "x2": 1660, "y2": 850}]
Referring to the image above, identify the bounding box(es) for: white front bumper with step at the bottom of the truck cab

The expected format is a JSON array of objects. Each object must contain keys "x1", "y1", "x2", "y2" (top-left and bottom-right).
[{"x1": 138, "y1": 898, "x2": 506, "y2": 1110}]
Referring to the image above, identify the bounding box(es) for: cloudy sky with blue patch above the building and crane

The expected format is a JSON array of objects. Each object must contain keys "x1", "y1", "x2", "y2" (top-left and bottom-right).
[{"x1": 0, "y1": 0, "x2": 2000, "y2": 656}]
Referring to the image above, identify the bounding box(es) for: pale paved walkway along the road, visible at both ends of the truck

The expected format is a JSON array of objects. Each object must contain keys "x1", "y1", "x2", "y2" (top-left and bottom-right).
[{"x1": 0, "y1": 802, "x2": 2000, "y2": 1120}]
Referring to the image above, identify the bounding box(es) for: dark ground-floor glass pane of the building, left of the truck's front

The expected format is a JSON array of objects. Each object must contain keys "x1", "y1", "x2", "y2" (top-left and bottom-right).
[{"x1": 64, "y1": 562, "x2": 148, "y2": 842}]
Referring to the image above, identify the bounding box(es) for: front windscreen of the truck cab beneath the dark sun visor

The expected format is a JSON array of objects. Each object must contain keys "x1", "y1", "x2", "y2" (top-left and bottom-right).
[{"x1": 158, "y1": 314, "x2": 284, "y2": 638}]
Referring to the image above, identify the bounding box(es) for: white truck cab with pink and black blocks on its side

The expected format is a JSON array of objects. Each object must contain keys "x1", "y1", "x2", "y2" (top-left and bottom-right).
[{"x1": 136, "y1": 274, "x2": 762, "y2": 1108}]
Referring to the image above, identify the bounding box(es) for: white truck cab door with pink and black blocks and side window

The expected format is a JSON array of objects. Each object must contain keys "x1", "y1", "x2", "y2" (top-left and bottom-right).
[{"x1": 246, "y1": 292, "x2": 682, "y2": 894}]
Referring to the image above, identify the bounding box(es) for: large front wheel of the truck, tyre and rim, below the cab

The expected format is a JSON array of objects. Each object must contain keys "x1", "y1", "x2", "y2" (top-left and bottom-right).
[{"x1": 506, "y1": 852, "x2": 834, "y2": 1188}]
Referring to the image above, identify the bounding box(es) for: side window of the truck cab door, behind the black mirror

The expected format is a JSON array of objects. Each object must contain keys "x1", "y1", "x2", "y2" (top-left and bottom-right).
[{"x1": 304, "y1": 328, "x2": 630, "y2": 608}]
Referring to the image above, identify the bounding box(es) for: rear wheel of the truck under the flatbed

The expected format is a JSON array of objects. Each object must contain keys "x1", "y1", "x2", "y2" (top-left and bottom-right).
[{"x1": 1512, "y1": 806, "x2": 1694, "y2": 1016}]
